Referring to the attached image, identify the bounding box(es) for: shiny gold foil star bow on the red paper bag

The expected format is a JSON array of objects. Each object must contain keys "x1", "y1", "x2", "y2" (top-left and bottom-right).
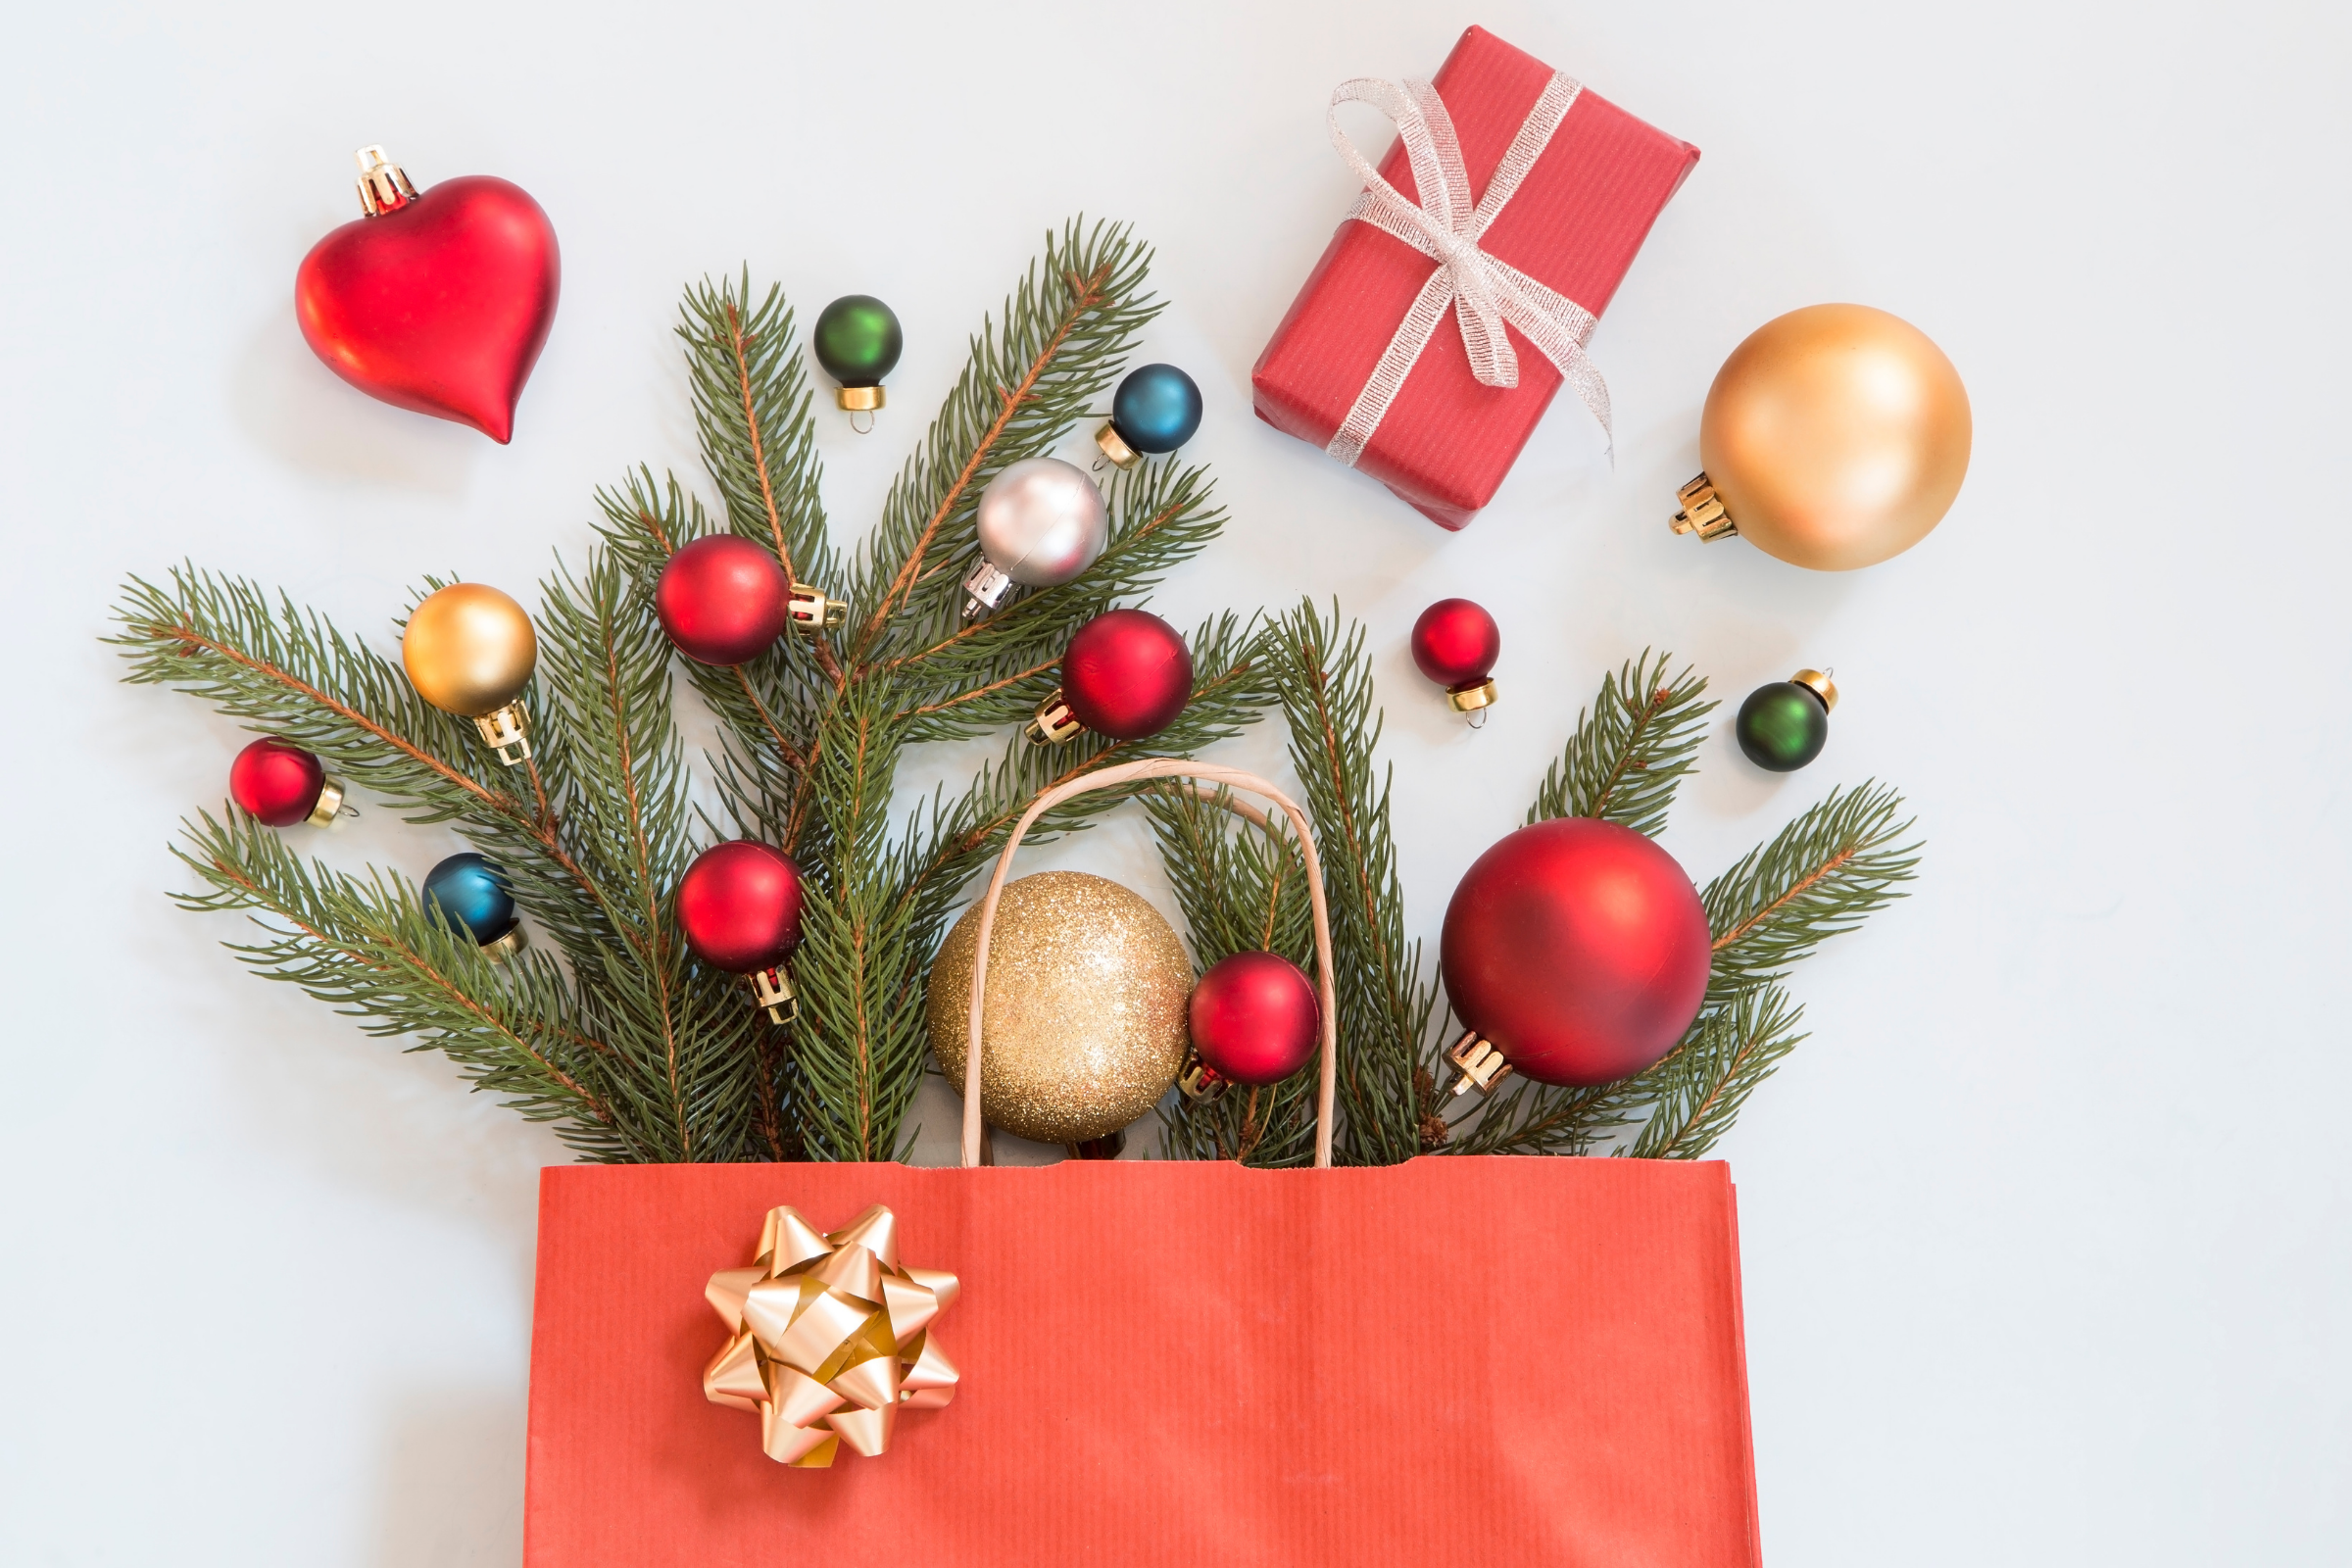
[{"x1": 704, "y1": 1203, "x2": 959, "y2": 1469}]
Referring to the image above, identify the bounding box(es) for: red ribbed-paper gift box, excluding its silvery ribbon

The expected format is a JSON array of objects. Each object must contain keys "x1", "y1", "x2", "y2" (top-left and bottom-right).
[{"x1": 1251, "y1": 28, "x2": 1698, "y2": 529}]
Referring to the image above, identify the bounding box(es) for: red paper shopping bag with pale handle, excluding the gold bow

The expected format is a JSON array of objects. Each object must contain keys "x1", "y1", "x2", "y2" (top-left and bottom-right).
[{"x1": 524, "y1": 761, "x2": 1759, "y2": 1568}]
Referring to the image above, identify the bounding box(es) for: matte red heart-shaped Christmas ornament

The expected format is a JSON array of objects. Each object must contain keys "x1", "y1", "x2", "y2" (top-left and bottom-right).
[{"x1": 294, "y1": 174, "x2": 563, "y2": 442}]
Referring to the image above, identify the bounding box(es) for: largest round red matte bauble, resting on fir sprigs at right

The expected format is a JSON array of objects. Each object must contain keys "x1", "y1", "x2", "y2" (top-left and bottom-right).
[{"x1": 1437, "y1": 818, "x2": 1712, "y2": 1086}]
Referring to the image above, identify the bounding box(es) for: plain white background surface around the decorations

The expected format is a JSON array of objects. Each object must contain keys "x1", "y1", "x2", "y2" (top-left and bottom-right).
[{"x1": 0, "y1": 0, "x2": 2352, "y2": 1568}]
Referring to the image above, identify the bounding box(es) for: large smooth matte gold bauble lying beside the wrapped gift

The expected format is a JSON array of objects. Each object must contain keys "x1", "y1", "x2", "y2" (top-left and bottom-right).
[{"x1": 1675, "y1": 306, "x2": 1971, "y2": 571}]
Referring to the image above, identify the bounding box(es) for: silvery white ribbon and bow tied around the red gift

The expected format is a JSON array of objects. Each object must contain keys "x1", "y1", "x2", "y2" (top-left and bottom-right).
[{"x1": 1324, "y1": 73, "x2": 1609, "y2": 467}]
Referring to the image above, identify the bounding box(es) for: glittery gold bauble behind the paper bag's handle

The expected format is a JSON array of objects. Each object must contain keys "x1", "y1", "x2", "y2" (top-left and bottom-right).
[{"x1": 924, "y1": 872, "x2": 1193, "y2": 1143}]
